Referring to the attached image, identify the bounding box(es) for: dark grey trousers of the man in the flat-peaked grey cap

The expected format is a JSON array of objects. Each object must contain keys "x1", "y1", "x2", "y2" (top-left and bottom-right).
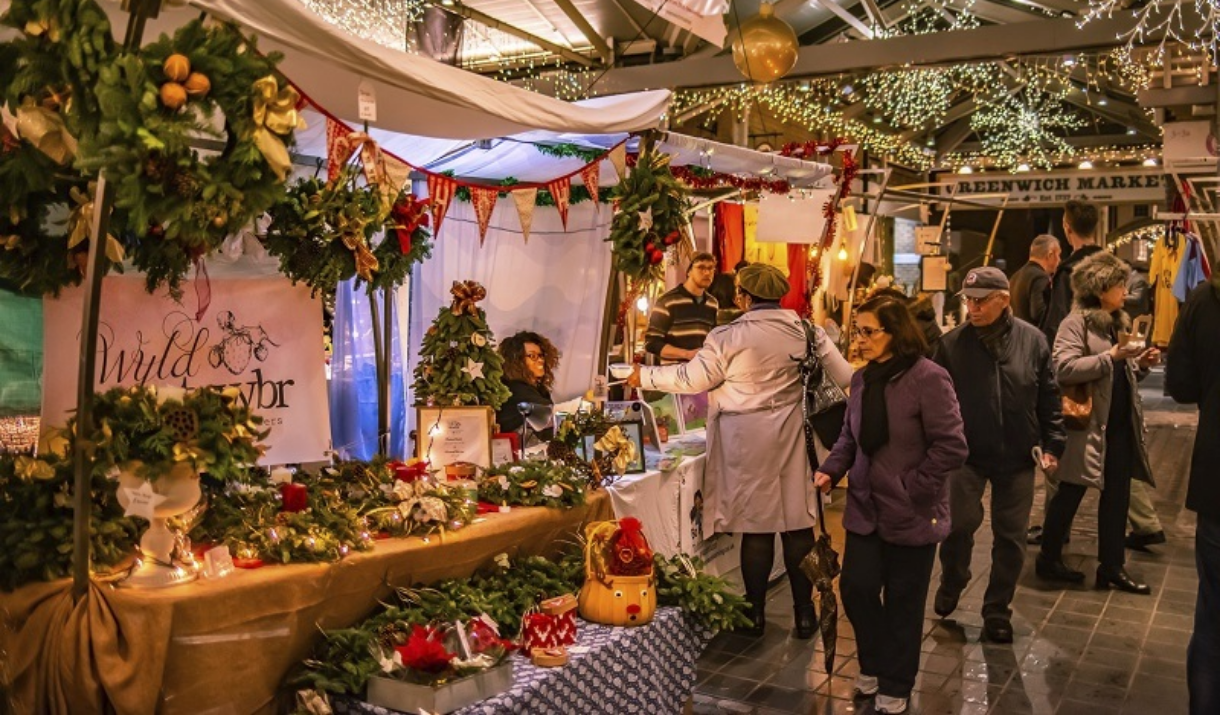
[{"x1": 941, "y1": 465, "x2": 1033, "y2": 621}]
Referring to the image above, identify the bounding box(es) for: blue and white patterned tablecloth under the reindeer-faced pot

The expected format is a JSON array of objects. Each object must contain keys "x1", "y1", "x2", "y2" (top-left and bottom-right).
[{"x1": 332, "y1": 608, "x2": 711, "y2": 715}]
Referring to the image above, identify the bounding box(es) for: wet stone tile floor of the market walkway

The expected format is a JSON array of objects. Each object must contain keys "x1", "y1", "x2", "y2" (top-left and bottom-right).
[{"x1": 693, "y1": 373, "x2": 1198, "y2": 715}]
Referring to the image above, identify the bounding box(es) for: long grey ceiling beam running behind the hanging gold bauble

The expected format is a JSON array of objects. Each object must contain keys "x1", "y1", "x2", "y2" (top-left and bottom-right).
[{"x1": 598, "y1": 17, "x2": 1193, "y2": 93}]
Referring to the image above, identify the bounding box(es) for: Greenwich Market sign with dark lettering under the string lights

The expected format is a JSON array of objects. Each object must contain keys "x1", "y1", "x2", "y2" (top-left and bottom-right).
[{"x1": 941, "y1": 170, "x2": 1165, "y2": 210}]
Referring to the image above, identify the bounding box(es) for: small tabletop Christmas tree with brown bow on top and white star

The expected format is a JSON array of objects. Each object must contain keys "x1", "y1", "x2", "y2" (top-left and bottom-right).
[{"x1": 411, "y1": 281, "x2": 510, "y2": 410}]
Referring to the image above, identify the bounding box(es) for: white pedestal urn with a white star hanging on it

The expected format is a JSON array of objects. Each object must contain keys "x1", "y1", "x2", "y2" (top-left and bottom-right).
[{"x1": 118, "y1": 462, "x2": 203, "y2": 588}]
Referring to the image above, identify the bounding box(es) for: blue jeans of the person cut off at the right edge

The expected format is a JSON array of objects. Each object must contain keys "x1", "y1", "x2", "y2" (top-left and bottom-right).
[{"x1": 1186, "y1": 514, "x2": 1220, "y2": 715}]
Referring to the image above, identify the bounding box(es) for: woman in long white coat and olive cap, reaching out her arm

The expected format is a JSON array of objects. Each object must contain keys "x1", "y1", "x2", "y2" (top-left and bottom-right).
[{"x1": 628, "y1": 264, "x2": 852, "y2": 638}]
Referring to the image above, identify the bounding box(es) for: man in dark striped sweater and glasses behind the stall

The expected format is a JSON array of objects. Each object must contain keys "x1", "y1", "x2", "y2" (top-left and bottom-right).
[{"x1": 644, "y1": 253, "x2": 720, "y2": 362}]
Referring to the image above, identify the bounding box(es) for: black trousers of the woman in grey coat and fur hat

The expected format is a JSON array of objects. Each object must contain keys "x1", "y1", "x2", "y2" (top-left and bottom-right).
[{"x1": 1042, "y1": 429, "x2": 1137, "y2": 570}]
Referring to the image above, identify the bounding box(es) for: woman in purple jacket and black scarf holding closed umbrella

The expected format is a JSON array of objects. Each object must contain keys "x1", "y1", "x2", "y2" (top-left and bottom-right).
[{"x1": 814, "y1": 298, "x2": 967, "y2": 714}]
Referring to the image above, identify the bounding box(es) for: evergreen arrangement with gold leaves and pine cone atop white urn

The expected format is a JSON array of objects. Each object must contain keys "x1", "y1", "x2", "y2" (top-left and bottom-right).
[{"x1": 65, "y1": 386, "x2": 268, "y2": 481}]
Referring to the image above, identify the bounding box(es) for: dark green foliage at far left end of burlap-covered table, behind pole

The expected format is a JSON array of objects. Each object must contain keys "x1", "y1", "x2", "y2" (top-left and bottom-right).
[{"x1": 0, "y1": 454, "x2": 140, "y2": 591}]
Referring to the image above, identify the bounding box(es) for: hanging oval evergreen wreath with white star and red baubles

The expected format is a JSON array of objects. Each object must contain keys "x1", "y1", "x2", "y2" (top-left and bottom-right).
[{"x1": 606, "y1": 140, "x2": 689, "y2": 283}]
